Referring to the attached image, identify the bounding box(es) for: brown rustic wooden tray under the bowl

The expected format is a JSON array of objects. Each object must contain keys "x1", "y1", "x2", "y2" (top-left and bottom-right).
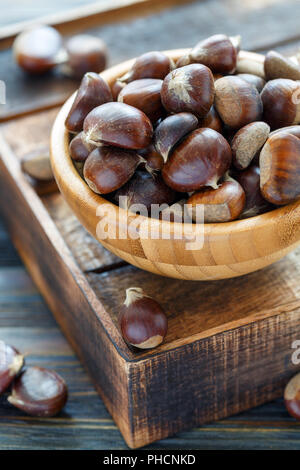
[{"x1": 0, "y1": 109, "x2": 300, "y2": 447}]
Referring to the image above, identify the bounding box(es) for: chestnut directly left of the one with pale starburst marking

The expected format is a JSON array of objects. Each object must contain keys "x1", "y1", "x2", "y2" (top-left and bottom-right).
[{"x1": 118, "y1": 78, "x2": 165, "y2": 122}]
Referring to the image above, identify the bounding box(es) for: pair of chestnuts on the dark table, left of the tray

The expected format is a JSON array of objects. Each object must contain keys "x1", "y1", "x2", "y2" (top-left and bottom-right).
[{"x1": 0, "y1": 341, "x2": 68, "y2": 417}]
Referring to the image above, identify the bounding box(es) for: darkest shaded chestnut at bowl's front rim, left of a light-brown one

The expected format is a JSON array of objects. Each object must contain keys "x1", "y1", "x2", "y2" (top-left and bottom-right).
[{"x1": 114, "y1": 171, "x2": 177, "y2": 211}]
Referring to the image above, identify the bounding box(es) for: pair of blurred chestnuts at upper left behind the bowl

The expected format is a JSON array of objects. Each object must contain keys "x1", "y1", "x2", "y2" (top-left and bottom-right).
[{"x1": 13, "y1": 25, "x2": 107, "y2": 79}]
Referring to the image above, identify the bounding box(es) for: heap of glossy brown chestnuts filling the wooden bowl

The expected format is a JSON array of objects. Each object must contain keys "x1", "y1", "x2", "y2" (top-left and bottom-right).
[{"x1": 65, "y1": 34, "x2": 300, "y2": 223}]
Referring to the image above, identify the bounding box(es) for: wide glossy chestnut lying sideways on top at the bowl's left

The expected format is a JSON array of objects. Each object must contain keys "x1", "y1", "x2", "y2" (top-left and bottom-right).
[{"x1": 83, "y1": 103, "x2": 153, "y2": 149}]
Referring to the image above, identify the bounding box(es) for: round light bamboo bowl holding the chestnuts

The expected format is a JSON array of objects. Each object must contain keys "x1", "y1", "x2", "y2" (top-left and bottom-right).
[{"x1": 51, "y1": 50, "x2": 300, "y2": 280}]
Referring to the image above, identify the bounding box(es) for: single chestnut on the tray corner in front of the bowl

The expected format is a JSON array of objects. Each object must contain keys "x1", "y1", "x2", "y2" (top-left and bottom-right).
[{"x1": 119, "y1": 287, "x2": 168, "y2": 349}]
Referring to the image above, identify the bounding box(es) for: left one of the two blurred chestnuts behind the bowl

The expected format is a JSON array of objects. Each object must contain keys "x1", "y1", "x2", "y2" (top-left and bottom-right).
[{"x1": 13, "y1": 26, "x2": 62, "y2": 74}]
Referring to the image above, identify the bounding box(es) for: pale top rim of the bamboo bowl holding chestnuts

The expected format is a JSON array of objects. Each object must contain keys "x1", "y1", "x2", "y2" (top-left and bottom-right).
[{"x1": 50, "y1": 49, "x2": 300, "y2": 241}]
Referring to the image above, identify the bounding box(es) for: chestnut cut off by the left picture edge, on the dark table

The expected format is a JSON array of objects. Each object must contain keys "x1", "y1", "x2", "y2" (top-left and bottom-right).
[{"x1": 0, "y1": 341, "x2": 24, "y2": 395}]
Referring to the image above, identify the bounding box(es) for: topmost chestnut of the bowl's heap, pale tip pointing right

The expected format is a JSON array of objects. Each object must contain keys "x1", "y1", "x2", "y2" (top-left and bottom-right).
[{"x1": 176, "y1": 34, "x2": 240, "y2": 74}]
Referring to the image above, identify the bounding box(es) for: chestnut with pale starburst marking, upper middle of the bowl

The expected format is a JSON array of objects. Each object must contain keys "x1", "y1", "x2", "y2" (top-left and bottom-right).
[{"x1": 161, "y1": 64, "x2": 214, "y2": 118}]
